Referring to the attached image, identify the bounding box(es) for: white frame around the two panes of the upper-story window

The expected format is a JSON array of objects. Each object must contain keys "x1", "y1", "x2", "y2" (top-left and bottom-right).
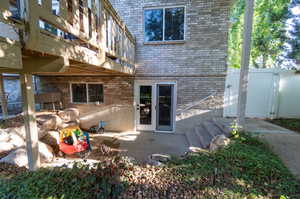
[{"x1": 143, "y1": 5, "x2": 187, "y2": 43}]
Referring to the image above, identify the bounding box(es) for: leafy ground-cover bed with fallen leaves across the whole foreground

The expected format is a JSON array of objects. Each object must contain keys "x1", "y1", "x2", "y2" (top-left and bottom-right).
[{"x1": 0, "y1": 135, "x2": 300, "y2": 199}]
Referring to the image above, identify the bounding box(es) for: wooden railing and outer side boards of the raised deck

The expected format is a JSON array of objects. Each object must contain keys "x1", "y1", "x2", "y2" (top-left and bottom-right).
[{"x1": 0, "y1": 0, "x2": 135, "y2": 70}]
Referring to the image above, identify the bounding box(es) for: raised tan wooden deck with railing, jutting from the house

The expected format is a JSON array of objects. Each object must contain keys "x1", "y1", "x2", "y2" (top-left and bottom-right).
[{"x1": 0, "y1": 0, "x2": 135, "y2": 75}]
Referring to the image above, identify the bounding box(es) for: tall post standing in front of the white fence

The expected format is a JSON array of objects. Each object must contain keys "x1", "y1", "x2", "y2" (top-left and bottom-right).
[{"x1": 237, "y1": 0, "x2": 254, "y2": 128}]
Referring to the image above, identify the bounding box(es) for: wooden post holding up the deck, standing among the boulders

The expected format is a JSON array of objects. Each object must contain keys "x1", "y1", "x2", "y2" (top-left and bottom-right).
[{"x1": 20, "y1": 74, "x2": 40, "y2": 171}]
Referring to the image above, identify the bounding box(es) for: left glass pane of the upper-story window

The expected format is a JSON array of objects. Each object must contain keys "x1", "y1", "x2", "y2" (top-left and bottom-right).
[{"x1": 144, "y1": 9, "x2": 163, "y2": 41}]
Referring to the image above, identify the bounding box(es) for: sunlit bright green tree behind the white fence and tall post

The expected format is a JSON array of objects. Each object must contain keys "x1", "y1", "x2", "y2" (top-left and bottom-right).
[{"x1": 228, "y1": 0, "x2": 291, "y2": 68}]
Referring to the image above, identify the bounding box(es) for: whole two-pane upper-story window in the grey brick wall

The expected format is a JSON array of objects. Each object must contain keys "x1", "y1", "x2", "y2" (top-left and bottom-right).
[{"x1": 144, "y1": 7, "x2": 185, "y2": 42}]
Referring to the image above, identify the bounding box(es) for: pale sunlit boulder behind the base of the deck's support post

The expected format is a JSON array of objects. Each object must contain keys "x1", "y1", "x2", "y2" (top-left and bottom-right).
[{"x1": 0, "y1": 142, "x2": 54, "y2": 167}]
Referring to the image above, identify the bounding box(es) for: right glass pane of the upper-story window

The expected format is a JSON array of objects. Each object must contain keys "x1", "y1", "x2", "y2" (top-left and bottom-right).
[{"x1": 165, "y1": 7, "x2": 184, "y2": 40}]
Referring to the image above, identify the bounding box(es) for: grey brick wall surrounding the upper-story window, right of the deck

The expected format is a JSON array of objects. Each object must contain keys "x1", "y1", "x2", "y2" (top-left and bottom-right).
[{"x1": 110, "y1": 0, "x2": 232, "y2": 113}]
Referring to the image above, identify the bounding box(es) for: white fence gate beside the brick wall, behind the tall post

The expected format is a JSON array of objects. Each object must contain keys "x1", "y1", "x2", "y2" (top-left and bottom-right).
[{"x1": 224, "y1": 69, "x2": 279, "y2": 118}]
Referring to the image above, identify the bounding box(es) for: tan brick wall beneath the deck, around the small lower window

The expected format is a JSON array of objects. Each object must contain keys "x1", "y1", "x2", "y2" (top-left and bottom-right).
[{"x1": 38, "y1": 76, "x2": 134, "y2": 131}]
